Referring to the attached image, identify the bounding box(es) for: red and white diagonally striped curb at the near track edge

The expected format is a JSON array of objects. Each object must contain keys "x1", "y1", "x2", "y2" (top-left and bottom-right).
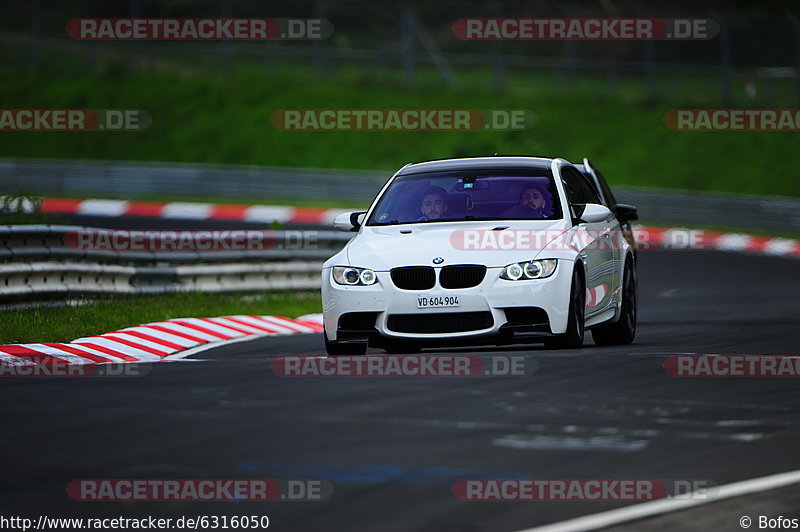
[{"x1": 0, "y1": 314, "x2": 323, "y2": 366}]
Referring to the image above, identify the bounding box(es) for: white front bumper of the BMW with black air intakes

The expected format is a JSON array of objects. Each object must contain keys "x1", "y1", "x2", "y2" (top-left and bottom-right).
[{"x1": 322, "y1": 260, "x2": 572, "y2": 344}]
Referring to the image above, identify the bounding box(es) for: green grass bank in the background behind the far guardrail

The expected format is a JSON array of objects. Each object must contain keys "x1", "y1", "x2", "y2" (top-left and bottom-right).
[{"x1": 0, "y1": 53, "x2": 800, "y2": 197}]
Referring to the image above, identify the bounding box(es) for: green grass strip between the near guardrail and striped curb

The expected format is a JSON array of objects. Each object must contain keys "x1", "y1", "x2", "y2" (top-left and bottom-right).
[{"x1": 0, "y1": 292, "x2": 322, "y2": 344}]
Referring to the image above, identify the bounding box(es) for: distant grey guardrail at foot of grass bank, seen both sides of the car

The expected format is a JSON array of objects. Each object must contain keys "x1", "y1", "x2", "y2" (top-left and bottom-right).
[{"x1": 0, "y1": 158, "x2": 800, "y2": 232}]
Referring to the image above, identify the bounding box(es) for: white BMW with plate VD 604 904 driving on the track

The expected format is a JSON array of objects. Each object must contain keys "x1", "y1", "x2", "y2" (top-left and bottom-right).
[{"x1": 322, "y1": 157, "x2": 636, "y2": 355}]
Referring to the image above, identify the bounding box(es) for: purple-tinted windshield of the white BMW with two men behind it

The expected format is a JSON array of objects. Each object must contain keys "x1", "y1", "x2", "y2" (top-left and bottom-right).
[{"x1": 367, "y1": 169, "x2": 561, "y2": 225}]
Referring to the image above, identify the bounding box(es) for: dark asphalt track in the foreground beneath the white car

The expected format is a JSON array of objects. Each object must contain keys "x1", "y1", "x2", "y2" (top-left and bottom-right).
[{"x1": 0, "y1": 251, "x2": 800, "y2": 531}]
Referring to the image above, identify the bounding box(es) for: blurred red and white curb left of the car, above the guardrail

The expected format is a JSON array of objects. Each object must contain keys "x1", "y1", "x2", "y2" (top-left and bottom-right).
[{"x1": 41, "y1": 198, "x2": 348, "y2": 225}]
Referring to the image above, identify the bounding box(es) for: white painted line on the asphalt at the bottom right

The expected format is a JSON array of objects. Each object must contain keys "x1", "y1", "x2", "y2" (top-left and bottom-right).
[{"x1": 517, "y1": 469, "x2": 800, "y2": 532}]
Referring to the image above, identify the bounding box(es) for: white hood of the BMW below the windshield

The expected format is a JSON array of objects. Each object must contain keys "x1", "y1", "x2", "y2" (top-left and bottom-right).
[{"x1": 346, "y1": 220, "x2": 569, "y2": 271}]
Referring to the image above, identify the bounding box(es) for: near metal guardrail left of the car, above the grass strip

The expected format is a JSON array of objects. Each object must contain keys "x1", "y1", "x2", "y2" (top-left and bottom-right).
[{"x1": 0, "y1": 225, "x2": 353, "y2": 303}]
